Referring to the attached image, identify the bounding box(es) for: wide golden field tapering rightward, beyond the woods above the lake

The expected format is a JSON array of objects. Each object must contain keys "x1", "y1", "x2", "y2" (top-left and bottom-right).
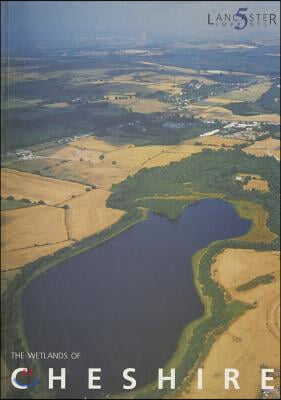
[{"x1": 25, "y1": 136, "x2": 244, "y2": 189}]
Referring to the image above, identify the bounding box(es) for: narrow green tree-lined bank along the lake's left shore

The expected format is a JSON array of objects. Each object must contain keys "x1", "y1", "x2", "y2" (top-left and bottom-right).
[{"x1": 1, "y1": 208, "x2": 147, "y2": 399}]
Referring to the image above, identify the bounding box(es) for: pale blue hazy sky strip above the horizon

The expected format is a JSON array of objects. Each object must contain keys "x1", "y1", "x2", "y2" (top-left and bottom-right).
[{"x1": 1, "y1": 1, "x2": 280, "y2": 50}]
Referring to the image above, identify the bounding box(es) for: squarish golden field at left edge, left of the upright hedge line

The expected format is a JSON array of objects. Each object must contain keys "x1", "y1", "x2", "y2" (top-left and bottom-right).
[{"x1": 1, "y1": 206, "x2": 68, "y2": 252}]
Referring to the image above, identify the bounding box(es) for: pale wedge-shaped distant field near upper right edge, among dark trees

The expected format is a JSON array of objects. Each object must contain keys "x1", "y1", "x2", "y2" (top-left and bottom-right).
[{"x1": 220, "y1": 81, "x2": 272, "y2": 102}]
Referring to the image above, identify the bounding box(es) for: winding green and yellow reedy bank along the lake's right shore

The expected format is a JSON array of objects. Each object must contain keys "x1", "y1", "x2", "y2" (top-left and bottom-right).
[{"x1": 111, "y1": 198, "x2": 279, "y2": 399}]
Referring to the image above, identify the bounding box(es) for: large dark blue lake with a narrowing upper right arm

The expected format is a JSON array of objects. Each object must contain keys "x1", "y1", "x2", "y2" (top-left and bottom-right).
[{"x1": 22, "y1": 199, "x2": 250, "y2": 398}]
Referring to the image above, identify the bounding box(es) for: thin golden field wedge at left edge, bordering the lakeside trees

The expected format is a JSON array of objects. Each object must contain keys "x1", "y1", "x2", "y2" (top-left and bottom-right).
[{"x1": 1, "y1": 240, "x2": 73, "y2": 275}]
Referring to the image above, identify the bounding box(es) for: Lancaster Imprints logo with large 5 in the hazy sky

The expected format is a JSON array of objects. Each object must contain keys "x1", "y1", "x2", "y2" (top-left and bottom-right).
[{"x1": 208, "y1": 7, "x2": 278, "y2": 31}]
